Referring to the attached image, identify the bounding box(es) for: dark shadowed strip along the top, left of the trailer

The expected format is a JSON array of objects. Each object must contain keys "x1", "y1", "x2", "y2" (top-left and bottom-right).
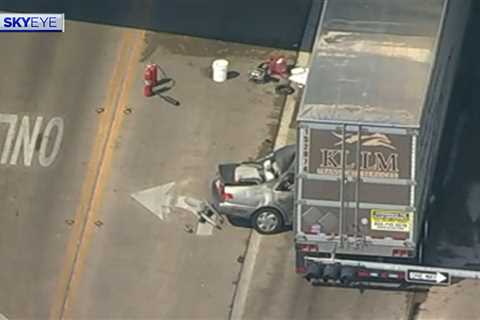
[{"x1": 0, "y1": 0, "x2": 312, "y2": 49}]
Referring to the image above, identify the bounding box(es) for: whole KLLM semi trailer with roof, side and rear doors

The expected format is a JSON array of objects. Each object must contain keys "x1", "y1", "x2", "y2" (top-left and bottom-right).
[{"x1": 293, "y1": 0, "x2": 480, "y2": 287}]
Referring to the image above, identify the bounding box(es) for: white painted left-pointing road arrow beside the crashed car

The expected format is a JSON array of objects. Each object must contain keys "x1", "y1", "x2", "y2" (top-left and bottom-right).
[{"x1": 130, "y1": 182, "x2": 213, "y2": 235}]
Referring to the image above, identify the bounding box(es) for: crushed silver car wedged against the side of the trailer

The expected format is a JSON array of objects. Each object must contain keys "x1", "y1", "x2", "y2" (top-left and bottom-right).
[{"x1": 212, "y1": 145, "x2": 295, "y2": 234}]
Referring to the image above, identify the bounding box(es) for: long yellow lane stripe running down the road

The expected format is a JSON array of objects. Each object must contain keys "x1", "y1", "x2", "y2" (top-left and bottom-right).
[{"x1": 49, "y1": 30, "x2": 145, "y2": 319}]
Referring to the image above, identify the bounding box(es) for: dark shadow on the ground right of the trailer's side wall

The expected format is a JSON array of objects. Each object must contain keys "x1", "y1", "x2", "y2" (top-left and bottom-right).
[{"x1": 425, "y1": 4, "x2": 480, "y2": 270}]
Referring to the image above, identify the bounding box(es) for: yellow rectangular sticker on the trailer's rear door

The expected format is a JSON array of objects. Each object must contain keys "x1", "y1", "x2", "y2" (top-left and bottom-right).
[{"x1": 370, "y1": 209, "x2": 413, "y2": 232}]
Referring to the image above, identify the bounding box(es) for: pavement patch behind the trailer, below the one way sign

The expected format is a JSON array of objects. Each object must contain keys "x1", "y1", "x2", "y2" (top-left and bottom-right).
[{"x1": 242, "y1": 234, "x2": 413, "y2": 320}]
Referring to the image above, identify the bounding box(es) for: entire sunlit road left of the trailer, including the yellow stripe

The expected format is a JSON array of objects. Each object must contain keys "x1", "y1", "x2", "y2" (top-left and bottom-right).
[{"x1": 0, "y1": 22, "x2": 296, "y2": 319}]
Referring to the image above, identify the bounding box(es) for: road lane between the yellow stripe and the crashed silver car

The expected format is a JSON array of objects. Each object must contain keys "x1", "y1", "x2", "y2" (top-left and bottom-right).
[{"x1": 57, "y1": 30, "x2": 292, "y2": 319}]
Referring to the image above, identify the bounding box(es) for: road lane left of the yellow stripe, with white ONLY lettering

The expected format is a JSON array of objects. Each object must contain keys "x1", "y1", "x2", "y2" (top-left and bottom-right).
[{"x1": 0, "y1": 23, "x2": 124, "y2": 319}]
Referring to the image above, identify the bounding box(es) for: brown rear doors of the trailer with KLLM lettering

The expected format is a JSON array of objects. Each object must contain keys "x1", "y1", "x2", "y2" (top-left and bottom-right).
[{"x1": 297, "y1": 123, "x2": 416, "y2": 255}]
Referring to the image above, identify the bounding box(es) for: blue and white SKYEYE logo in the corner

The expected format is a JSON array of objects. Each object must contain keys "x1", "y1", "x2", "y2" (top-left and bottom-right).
[{"x1": 0, "y1": 13, "x2": 65, "y2": 32}]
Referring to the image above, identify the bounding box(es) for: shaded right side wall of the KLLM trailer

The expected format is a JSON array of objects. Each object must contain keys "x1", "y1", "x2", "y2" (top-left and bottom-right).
[{"x1": 415, "y1": 0, "x2": 471, "y2": 241}]
